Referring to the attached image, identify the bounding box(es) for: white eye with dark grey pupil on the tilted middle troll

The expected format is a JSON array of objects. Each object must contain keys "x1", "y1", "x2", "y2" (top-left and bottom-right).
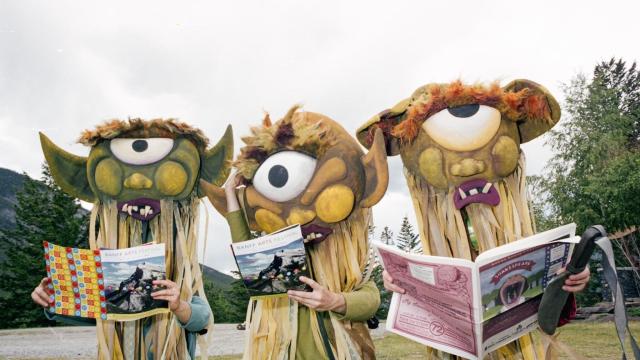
[{"x1": 253, "y1": 151, "x2": 317, "y2": 202}]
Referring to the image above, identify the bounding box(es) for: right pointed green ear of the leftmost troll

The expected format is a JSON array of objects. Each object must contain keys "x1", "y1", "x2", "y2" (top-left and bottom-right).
[{"x1": 198, "y1": 125, "x2": 233, "y2": 197}]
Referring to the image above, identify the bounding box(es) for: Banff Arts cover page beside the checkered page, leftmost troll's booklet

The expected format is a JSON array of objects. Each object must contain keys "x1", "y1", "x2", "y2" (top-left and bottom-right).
[{"x1": 100, "y1": 244, "x2": 169, "y2": 321}]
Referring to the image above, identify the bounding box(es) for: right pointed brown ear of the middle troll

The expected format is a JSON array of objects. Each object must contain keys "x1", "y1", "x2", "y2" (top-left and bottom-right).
[{"x1": 360, "y1": 129, "x2": 389, "y2": 208}]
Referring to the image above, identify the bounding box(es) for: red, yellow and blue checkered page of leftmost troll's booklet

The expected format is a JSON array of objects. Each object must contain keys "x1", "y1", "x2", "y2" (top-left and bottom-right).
[{"x1": 44, "y1": 241, "x2": 107, "y2": 320}]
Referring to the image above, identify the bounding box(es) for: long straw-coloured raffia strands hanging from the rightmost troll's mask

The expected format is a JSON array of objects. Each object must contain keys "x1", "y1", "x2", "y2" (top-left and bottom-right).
[{"x1": 405, "y1": 155, "x2": 544, "y2": 360}]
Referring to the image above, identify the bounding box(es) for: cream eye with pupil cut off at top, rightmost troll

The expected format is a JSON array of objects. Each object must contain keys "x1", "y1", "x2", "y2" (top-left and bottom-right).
[{"x1": 422, "y1": 104, "x2": 501, "y2": 151}]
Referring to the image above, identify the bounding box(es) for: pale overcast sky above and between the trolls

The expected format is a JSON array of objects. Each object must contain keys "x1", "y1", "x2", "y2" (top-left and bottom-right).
[{"x1": 0, "y1": 0, "x2": 640, "y2": 271}]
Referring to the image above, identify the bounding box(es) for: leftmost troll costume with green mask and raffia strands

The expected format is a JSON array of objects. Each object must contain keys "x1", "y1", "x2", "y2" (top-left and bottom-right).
[{"x1": 40, "y1": 119, "x2": 233, "y2": 359}]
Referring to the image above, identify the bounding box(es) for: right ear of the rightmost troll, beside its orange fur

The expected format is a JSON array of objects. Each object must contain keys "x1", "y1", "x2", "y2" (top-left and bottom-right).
[{"x1": 504, "y1": 79, "x2": 560, "y2": 143}]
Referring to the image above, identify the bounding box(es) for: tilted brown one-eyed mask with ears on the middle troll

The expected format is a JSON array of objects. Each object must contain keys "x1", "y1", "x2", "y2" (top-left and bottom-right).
[{"x1": 205, "y1": 107, "x2": 388, "y2": 243}]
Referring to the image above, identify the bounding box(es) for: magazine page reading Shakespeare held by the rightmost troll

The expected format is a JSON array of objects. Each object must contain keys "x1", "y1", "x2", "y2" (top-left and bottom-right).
[{"x1": 476, "y1": 225, "x2": 579, "y2": 351}]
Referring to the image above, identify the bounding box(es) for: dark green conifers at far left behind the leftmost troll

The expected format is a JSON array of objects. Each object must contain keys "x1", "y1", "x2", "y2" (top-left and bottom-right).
[{"x1": 0, "y1": 166, "x2": 88, "y2": 328}]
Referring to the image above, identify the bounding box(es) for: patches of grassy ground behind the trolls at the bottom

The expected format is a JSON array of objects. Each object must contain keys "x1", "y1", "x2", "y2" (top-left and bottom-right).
[{"x1": 209, "y1": 321, "x2": 640, "y2": 360}]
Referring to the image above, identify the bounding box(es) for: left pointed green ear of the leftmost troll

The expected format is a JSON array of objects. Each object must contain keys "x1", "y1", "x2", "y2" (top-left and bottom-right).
[{"x1": 40, "y1": 133, "x2": 96, "y2": 202}]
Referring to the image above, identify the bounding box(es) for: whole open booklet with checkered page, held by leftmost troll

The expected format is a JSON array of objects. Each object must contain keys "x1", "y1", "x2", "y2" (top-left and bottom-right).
[{"x1": 44, "y1": 242, "x2": 169, "y2": 321}]
